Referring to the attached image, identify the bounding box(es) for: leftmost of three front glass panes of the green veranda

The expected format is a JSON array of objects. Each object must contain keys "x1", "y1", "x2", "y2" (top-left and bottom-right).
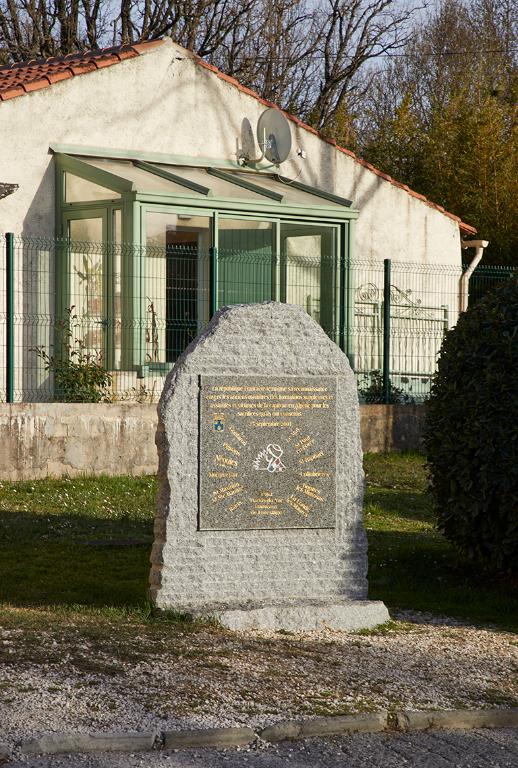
[{"x1": 145, "y1": 211, "x2": 212, "y2": 363}]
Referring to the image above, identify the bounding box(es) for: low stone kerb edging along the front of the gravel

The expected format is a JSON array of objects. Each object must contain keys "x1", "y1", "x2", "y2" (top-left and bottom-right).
[{"x1": 13, "y1": 707, "x2": 518, "y2": 758}]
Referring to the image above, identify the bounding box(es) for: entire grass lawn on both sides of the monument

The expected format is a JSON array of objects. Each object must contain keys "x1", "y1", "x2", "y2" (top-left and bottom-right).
[{"x1": 0, "y1": 454, "x2": 518, "y2": 631}]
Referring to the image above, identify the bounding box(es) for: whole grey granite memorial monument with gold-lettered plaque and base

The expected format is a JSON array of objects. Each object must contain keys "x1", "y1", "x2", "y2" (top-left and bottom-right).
[{"x1": 150, "y1": 302, "x2": 389, "y2": 630}]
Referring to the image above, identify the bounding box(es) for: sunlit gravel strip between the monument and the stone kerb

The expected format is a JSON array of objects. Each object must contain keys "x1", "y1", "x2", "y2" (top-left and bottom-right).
[{"x1": 0, "y1": 613, "x2": 518, "y2": 752}]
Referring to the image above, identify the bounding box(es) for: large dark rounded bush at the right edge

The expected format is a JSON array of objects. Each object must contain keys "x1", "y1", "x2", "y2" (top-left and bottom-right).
[{"x1": 425, "y1": 277, "x2": 518, "y2": 575}]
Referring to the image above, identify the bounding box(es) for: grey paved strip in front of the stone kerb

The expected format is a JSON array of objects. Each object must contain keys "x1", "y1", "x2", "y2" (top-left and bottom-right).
[{"x1": 6, "y1": 729, "x2": 518, "y2": 768}]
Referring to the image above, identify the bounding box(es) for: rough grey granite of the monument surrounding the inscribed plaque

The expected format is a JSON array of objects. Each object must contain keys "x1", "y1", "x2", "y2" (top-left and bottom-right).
[{"x1": 150, "y1": 302, "x2": 388, "y2": 626}]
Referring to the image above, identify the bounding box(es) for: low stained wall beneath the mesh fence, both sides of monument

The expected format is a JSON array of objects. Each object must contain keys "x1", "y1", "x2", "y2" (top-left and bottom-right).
[{"x1": 0, "y1": 403, "x2": 424, "y2": 480}]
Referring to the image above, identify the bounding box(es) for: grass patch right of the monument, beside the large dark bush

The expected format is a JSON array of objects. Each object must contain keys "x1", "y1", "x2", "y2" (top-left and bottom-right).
[{"x1": 364, "y1": 454, "x2": 518, "y2": 632}]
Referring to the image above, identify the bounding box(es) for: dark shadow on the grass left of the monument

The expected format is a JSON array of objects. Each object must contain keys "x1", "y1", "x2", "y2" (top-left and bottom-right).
[{"x1": 0, "y1": 512, "x2": 153, "y2": 608}]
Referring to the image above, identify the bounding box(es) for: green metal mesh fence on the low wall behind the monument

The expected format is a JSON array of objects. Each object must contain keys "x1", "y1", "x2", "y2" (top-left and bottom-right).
[{"x1": 0, "y1": 237, "x2": 511, "y2": 403}]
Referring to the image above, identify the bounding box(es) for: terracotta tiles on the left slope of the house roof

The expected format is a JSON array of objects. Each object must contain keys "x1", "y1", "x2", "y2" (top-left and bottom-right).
[{"x1": 0, "y1": 40, "x2": 162, "y2": 101}]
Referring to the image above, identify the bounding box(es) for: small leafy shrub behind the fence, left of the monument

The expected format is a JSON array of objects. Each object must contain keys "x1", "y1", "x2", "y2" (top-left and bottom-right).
[{"x1": 32, "y1": 306, "x2": 111, "y2": 403}]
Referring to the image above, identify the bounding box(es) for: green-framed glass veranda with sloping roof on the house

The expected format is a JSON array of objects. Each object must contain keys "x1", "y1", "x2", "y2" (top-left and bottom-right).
[{"x1": 53, "y1": 147, "x2": 358, "y2": 373}]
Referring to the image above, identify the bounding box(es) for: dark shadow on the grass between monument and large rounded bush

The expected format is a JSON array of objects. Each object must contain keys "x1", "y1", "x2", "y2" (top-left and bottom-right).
[{"x1": 368, "y1": 531, "x2": 518, "y2": 632}]
